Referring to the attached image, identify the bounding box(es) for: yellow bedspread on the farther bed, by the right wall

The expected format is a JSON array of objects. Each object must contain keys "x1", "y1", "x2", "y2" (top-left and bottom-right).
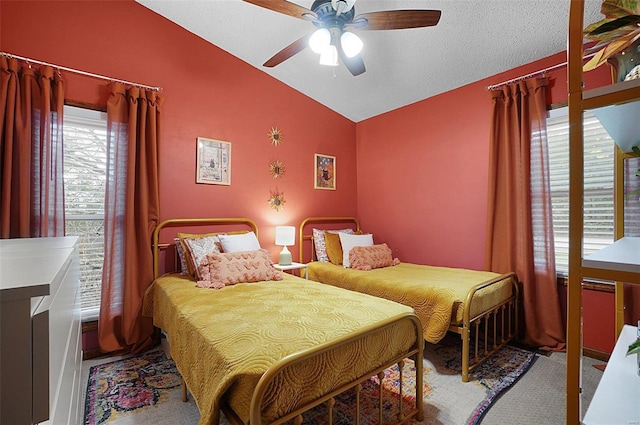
[{"x1": 309, "y1": 262, "x2": 512, "y2": 344}]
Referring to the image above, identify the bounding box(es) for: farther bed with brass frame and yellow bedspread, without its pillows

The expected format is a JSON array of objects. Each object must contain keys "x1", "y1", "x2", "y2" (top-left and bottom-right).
[{"x1": 299, "y1": 217, "x2": 518, "y2": 382}]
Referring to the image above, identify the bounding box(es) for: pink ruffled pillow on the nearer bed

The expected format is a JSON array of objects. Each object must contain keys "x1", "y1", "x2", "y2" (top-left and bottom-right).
[{"x1": 196, "y1": 249, "x2": 282, "y2": 289}]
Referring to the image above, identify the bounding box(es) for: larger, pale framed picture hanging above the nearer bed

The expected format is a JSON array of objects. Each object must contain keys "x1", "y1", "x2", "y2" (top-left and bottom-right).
[{"x1": 196, "y1": 137, "x2": 231, "y2": 185}]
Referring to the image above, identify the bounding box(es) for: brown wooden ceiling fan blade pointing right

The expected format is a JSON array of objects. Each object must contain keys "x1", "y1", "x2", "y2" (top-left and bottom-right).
[{"x1": 345, "y1": 10, "x2": 442, "y2": 30}]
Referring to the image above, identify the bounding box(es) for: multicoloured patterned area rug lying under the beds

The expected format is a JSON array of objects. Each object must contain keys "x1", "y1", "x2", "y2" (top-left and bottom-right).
[{"x1": 85, "y1": 335, "x2": 535, "y2": 425}]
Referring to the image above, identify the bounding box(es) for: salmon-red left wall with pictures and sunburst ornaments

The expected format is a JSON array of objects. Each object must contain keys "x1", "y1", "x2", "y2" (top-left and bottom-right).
[{"x1": 0, "y1": 0, "x2": 357, "y2": 259}]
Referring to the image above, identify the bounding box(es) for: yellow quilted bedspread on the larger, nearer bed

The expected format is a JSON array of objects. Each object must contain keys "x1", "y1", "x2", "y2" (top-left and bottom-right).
[{"x1": 144, "y1": 274, "x2": 419, "y2": 424}]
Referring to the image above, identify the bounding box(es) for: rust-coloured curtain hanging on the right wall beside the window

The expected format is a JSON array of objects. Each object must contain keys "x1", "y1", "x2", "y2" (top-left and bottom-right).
[{"x1": 485, "y1": 78, "x2": 565, "y2": 350}]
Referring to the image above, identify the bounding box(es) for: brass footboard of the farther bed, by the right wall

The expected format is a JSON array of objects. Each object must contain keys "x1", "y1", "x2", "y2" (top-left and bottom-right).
[{"x1": 449, "y1": 273, "x2": 520, "y2": 382}]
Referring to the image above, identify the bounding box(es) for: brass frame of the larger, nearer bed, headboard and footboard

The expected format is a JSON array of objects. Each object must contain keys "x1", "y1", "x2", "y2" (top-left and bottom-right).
[{"x1": 152, "y1": 218, "x2": 424, "y2": 425}]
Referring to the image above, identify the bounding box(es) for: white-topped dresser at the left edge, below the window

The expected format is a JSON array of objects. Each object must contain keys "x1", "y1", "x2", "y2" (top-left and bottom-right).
[{"x1": 0, "y1": 237, "x2": 82, "y2": 425}]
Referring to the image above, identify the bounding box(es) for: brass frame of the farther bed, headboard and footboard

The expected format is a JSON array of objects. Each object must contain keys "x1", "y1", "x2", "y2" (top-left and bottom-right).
[{"x1": 298, "y1": 216, "x2": 519, "y2": 382}]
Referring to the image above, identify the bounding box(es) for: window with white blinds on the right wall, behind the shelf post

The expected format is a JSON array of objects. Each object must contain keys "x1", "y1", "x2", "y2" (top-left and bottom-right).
[{"x1": 547, "y1": 108, "x2": 615, "y2": 275}]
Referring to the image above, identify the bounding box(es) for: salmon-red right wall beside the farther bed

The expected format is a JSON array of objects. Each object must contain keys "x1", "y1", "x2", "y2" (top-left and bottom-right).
[{"x1": 356, "y1": 53, "x2": 610, "y2": 269}]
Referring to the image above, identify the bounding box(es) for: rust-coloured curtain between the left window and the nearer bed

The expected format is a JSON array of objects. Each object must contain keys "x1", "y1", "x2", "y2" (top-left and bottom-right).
[{"x1": 98, "y1": 83, "x2": 163, "y2": 352}]
